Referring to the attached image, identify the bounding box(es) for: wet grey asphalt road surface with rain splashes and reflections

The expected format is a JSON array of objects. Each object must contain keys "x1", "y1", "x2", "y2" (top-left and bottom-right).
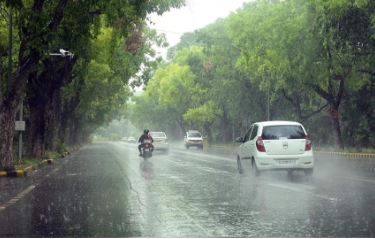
[{"x1": 0, "y1": 142, "x2": 375, "y2": 237}]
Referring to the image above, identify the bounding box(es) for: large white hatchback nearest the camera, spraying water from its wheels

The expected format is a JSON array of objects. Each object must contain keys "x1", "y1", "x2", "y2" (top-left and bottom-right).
[{"x1": 236, "y1": 121, "x2": 314, "y2": 176}]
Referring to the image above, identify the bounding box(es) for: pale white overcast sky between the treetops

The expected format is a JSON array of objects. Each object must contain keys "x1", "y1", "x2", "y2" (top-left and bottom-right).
[{"x1": 149, "y1": 0, "x2": 252, "y2": 56}]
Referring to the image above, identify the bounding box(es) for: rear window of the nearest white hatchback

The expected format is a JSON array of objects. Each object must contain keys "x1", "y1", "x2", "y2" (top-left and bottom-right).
[{"x1": 262, "y1": 125, "x2": 306, "y2": 140}]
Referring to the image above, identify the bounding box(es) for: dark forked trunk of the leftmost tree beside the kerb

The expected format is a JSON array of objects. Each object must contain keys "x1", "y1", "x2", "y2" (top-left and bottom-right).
[{"x1": 0, "y1": 0, "x2": 68, "y2": 169}]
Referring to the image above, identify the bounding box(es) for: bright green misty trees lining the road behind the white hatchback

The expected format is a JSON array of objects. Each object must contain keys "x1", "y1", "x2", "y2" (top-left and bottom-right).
[{"x1": 129, "y1": 0, "x2": 375, "y2": 151}]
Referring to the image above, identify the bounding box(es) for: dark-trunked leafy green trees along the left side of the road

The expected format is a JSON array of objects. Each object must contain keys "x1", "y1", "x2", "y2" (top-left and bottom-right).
[{"x1": 0, "y1": 0, "x2": 183, "y2": 170}]
